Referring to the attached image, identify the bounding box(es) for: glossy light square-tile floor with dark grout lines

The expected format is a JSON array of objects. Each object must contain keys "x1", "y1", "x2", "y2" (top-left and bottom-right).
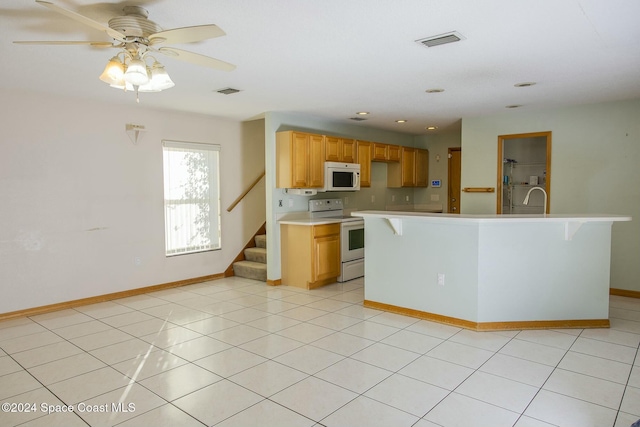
[{"x1": 0, "y1": 278, "x2": 640, "y2": 427}]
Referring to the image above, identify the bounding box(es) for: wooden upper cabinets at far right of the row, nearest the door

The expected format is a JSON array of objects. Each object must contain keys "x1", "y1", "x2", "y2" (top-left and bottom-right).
[{"x1": 387, "y1": 147, "x2": 429, "y2": 188}]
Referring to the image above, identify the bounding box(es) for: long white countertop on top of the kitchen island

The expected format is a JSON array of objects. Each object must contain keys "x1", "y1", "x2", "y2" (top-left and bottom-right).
[{"x1": 351, "y1": 211, "x2": 631, "y2": 223}]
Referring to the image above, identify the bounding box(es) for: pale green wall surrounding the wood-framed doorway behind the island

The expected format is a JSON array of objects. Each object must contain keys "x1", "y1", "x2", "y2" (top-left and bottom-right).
[{"x1": 461, "y1": 100, "x2": 640, "y2": 291}]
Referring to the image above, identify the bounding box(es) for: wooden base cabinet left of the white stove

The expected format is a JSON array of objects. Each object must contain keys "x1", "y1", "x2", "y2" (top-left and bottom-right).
[{"x1": 280, "y1": 223, "x2": 340, "y2": 289}]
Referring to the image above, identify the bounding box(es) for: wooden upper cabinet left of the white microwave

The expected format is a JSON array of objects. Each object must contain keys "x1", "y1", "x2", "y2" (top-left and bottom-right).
[{"x1": 276, "y1": 131, "x2": 325, "y2": 188}]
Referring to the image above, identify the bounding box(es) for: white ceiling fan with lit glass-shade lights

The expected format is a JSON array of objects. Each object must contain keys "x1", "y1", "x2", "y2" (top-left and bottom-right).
[{"x1": 14, "y1": 0, "x2": 236, "y2": 97}]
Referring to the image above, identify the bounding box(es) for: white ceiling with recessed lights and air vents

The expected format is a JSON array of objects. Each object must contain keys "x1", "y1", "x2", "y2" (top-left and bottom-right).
[{"x1": 0, "y1": 0, "x2": 640, "y2": 134}]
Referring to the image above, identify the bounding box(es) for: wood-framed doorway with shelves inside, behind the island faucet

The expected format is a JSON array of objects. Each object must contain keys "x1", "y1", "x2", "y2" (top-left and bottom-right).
[{"x1": 496, "y1": 132, "x2": 551, "y2": 214}]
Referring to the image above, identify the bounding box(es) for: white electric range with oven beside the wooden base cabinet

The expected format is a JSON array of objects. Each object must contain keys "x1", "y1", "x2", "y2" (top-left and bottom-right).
[{"x1": 309, "y1": 199, "x2": 364, "y2": 282}]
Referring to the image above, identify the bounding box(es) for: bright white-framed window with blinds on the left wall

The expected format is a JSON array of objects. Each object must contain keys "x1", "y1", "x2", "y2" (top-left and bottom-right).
[{"x1": 162, "y1": 140, "x2": 221, "y2": 256}]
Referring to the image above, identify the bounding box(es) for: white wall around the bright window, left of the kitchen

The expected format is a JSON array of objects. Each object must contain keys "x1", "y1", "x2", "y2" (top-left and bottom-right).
[{"x1": 0, "y1": 88, "x2": 265, "y2": 313}]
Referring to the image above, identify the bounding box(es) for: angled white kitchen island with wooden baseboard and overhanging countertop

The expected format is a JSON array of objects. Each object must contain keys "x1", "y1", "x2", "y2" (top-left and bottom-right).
[{"x1": 352, "y1": 211, "x2": 631, "y2": 330}]
